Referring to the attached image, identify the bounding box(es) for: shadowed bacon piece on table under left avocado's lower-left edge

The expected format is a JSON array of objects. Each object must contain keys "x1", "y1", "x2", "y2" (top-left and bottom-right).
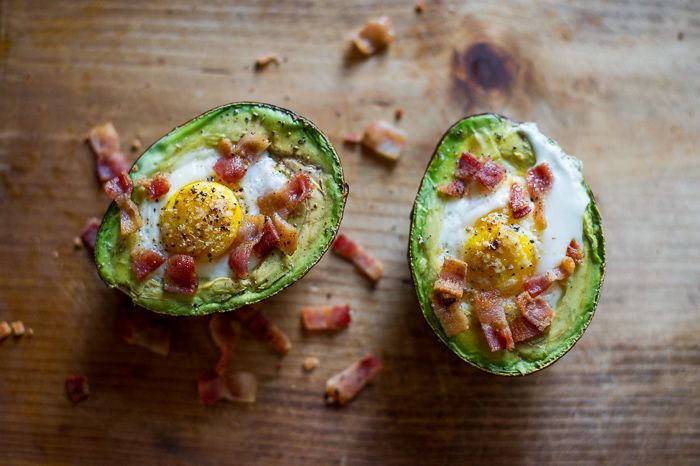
[{"x1": 116, "y1": 309, "x2": 171, "y2": 356}]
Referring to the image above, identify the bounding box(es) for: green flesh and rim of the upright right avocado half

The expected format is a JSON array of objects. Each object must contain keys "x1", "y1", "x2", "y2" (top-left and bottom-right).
[{"x1": 408, "y1": 114, "x2": 605, "y2": 376}]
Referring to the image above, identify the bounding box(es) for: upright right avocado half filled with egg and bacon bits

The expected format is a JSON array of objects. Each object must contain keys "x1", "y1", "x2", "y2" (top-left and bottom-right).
[{"x1": 408, "y1": 114, "x2": 605, "y2": 376}]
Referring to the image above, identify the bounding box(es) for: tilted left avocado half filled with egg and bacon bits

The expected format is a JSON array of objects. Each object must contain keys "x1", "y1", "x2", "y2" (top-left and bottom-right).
[{"x1": 95, "y1": 102, "x2": 348, "y2": 316}]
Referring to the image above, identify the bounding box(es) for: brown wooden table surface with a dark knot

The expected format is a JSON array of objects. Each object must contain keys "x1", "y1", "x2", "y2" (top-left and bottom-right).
[{"x1": 0, "y1": 0, "x2": 700, "y2": 465}]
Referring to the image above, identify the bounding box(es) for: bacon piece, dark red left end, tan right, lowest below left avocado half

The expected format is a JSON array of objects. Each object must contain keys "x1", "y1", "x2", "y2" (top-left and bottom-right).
[{"x1": 197, "y1": 371, "x2": 258, "y2": 405}]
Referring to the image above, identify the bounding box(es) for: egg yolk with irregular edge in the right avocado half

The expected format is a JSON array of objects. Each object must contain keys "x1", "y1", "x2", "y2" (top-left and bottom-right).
[{"x1": 464, "y1": 210, "x2": 537, "y2": 296}]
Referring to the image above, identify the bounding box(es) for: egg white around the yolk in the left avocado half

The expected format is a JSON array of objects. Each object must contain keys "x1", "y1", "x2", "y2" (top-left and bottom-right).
[{"x1": 136, "y1": 149, "x2": 288, "y2": 280}]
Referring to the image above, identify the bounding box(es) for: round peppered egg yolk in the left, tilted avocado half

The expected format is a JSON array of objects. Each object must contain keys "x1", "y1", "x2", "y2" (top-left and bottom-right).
[{"x1": 158, "y1": 181, "x2": 243, "y2": 259}]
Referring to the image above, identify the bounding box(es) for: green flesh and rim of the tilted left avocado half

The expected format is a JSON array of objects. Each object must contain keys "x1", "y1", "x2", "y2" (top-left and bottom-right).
[{"x1": 95, "y1": 102, "x2": 348, "y2": 316}]
